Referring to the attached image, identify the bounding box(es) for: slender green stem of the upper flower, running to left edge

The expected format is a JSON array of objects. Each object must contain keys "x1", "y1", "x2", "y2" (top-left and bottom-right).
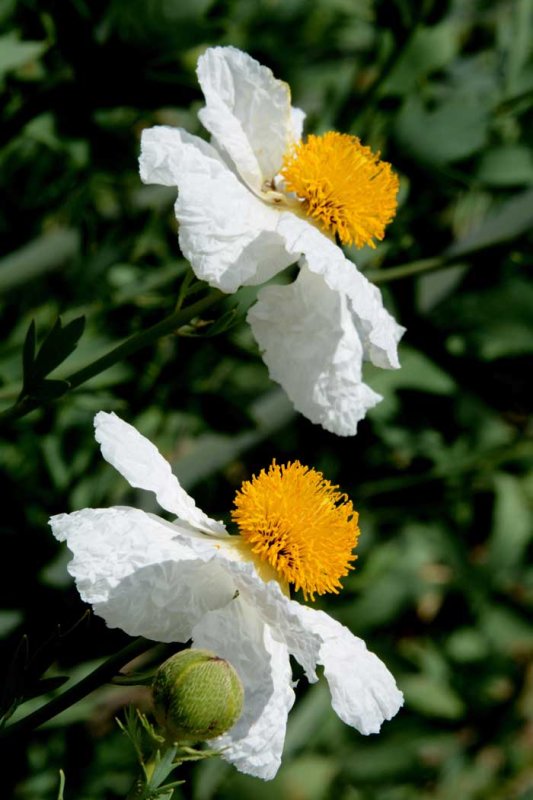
[{"x1": 0, "y1": 289, "x2": 223, "y2": 423}]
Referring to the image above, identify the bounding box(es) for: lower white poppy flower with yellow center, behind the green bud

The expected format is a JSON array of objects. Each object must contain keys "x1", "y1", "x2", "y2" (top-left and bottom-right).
[{"x1": 51, "y1": 412, "x2": 403, "y2": 779}]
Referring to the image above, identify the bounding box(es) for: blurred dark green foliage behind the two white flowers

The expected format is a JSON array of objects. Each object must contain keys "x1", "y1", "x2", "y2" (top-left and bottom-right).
[{"x1": 0, "y1": 0, "x2": 533, "y2": 800}]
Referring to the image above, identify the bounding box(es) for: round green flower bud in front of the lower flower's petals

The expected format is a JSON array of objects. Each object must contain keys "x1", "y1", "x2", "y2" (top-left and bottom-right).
[{"x1": 152, "y1": 650, "x2": 244, "y2": 742}]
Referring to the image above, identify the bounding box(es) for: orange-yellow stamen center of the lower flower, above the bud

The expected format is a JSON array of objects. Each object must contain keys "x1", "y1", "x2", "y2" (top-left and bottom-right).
[{"x1": 231, "y1": 461, "x2": 359, "y2": 600}]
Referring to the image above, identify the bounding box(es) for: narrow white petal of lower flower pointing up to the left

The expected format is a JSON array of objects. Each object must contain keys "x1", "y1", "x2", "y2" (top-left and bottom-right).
[{"x1": 94, "y1": 411, "x2": 223, "y2": 536}]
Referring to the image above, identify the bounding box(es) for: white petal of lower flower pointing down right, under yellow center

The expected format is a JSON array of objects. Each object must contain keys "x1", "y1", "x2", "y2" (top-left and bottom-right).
[{"x1": 218, "y1": 562, "x2": 403, "y2": 734}]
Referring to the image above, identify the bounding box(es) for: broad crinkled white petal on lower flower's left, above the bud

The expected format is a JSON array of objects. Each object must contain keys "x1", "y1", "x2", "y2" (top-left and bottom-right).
[{"x1": 50, "y1": 507, "x2": 235, "y2": 642}]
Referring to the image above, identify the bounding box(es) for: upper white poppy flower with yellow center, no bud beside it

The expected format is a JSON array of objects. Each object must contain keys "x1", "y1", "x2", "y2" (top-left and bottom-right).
[{"x1": 140, "y1": 47, "x2": 404, "y2": 436}]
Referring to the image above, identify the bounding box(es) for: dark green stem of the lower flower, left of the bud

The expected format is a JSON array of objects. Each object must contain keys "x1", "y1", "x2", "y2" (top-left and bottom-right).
[{"x1": 0, "y1": 636, "x2": 154, "y2": 739}]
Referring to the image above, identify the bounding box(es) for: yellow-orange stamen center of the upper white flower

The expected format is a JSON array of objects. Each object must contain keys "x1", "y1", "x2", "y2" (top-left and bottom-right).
[{"x1": 280, "y1": 131, "x2": 399, "y2": 247}]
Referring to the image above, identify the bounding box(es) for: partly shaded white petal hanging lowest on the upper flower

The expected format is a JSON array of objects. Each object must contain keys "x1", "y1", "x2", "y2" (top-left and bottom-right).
[{"x1": 247, "y1": 267, "x2": 381, "y2": 436}]
